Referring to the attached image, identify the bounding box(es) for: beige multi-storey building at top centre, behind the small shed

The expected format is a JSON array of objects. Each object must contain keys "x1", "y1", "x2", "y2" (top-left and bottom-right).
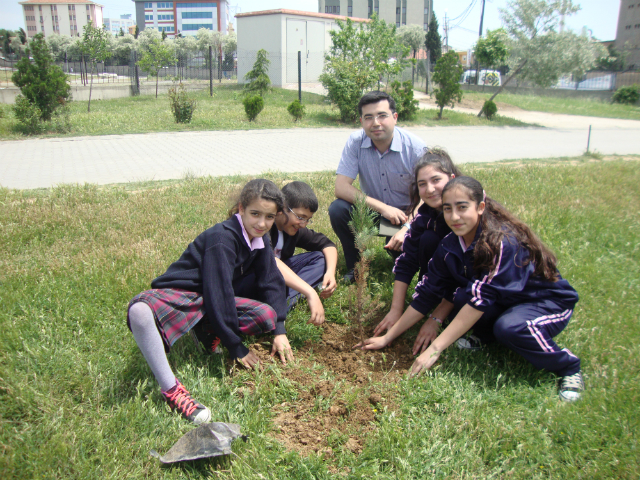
[{"x1": 318, "y1": 0, "x2": 433, "y2": 32}]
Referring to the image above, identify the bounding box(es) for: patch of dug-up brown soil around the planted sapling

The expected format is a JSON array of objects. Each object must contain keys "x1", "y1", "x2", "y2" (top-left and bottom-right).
[{"x1": 230, "y1": 324, "x2": 413, "y2": 457}]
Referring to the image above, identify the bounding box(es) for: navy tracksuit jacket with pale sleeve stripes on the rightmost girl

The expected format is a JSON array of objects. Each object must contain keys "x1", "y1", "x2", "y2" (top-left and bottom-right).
[{"x1": 411, "y1": 227, "x2": 578, "y2": 315}]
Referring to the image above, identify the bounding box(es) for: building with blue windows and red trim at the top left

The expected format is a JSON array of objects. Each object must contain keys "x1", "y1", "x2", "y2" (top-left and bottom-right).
[{"x1": 133, "y1": 0, "x2": 229, "y2": 37}]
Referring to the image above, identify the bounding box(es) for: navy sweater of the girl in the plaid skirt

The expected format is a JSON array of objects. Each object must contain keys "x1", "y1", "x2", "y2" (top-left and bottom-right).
[{"x1": 151, "y1": 216, "x2": 287, "y2": 358}]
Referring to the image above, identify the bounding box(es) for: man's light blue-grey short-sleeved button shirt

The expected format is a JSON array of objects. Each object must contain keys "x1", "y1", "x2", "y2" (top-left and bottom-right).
[{"x1": 336, "y1": 127, "x2": 425, "y2": 209}]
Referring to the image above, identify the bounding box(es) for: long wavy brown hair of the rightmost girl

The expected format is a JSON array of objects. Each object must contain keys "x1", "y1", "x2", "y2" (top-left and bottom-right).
[{"x1": 442, "y1": 177, "x2": 559, "y2": 282}]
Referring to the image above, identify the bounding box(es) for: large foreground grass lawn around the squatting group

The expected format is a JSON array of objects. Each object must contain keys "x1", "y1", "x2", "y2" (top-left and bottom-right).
[{"x1": 0, "y1": 158, "x2": 640, "y2": 480}]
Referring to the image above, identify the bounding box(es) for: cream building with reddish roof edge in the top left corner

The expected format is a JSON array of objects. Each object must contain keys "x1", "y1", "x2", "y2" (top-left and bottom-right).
[{"x1": 18, "y1": 0, "x2": 103, "y2": 37}]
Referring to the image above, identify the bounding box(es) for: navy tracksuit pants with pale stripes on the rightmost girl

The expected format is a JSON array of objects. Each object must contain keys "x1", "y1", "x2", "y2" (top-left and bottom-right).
[{"x1": 449, "y1": 289, "x2": 580, "y2": 377}]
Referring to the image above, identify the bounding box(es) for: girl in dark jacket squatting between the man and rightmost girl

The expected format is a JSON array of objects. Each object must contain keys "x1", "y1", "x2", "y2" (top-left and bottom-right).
[{"x1": 373, "y1": 148, "x2": 462, "y2": 338}]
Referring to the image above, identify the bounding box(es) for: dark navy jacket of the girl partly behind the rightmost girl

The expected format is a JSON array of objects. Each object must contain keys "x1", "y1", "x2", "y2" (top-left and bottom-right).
[{"x1": 393, "y1": 203, "x2": 451, "y2": 284}]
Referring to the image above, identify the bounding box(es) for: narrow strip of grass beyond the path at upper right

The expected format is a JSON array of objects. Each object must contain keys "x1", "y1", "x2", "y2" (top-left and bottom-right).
[{"x1": 464, "y1": 91, "x2": 640, "y2": 120}]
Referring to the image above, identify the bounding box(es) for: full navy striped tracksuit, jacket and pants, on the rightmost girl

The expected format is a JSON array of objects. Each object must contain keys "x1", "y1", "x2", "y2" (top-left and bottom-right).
[{"x1": 411, "y1": 227, "x2": 580, "y2": 376}]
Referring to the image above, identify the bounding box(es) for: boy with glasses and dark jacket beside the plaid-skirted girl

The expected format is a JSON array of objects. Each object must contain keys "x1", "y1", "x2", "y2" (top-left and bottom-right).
[{"x1": 271, "y1": 182, "x2": 338, "y2": 325}]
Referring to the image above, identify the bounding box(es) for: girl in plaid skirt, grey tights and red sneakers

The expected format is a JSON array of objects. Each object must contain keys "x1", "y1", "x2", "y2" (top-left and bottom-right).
[{"x1": 127, "y1": 179, "x2": 293, "y2": 424}]
